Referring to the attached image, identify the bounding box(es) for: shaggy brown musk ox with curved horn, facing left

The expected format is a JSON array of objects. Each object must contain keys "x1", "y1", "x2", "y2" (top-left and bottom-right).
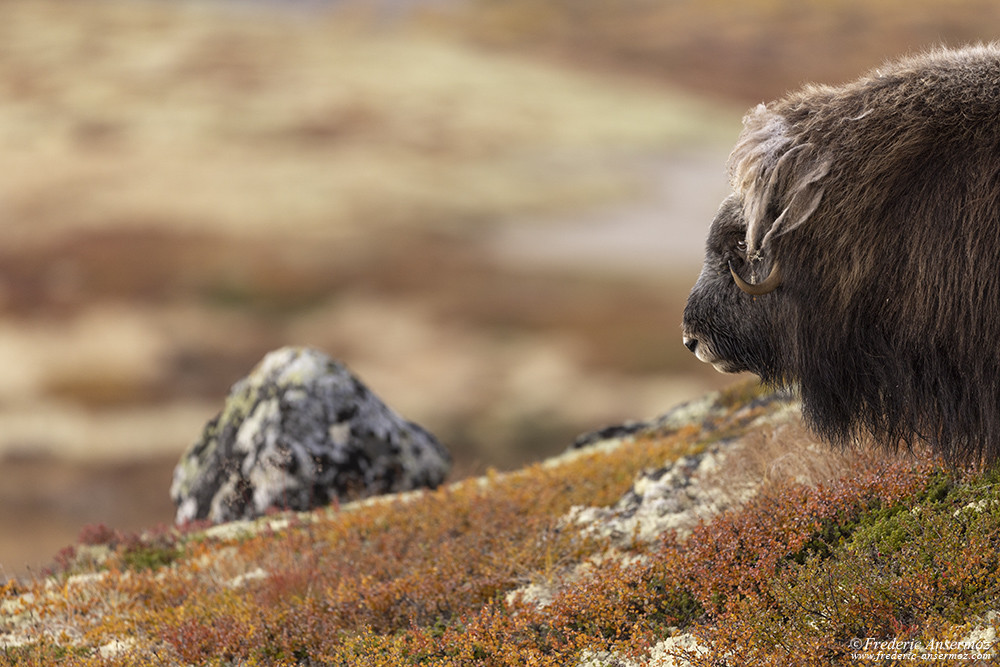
[{"x1": 683, "y1": 44, "x2": 1000, "y2": 462}]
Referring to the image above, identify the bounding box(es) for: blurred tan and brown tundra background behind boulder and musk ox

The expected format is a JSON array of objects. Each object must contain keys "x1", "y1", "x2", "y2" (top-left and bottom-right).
[{"x1": 0, "y1": 0, "x2": 1000, "y2": 580}]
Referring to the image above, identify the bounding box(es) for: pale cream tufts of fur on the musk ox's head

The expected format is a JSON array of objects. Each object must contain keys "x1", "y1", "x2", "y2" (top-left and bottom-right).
[{"x1": 729, "y1": 104, "x2": 830, "y2": 260}]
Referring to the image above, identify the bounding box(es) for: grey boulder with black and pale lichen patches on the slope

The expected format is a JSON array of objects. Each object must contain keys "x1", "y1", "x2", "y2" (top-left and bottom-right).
[{"x1": 170, "y1": 347, "x2": 451, "y2": 524}]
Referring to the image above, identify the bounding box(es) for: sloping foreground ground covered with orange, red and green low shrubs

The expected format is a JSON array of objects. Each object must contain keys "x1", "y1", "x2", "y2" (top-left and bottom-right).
[{"x1": 0, "y1": 388, "x2": 1000, "y2": 665}]
